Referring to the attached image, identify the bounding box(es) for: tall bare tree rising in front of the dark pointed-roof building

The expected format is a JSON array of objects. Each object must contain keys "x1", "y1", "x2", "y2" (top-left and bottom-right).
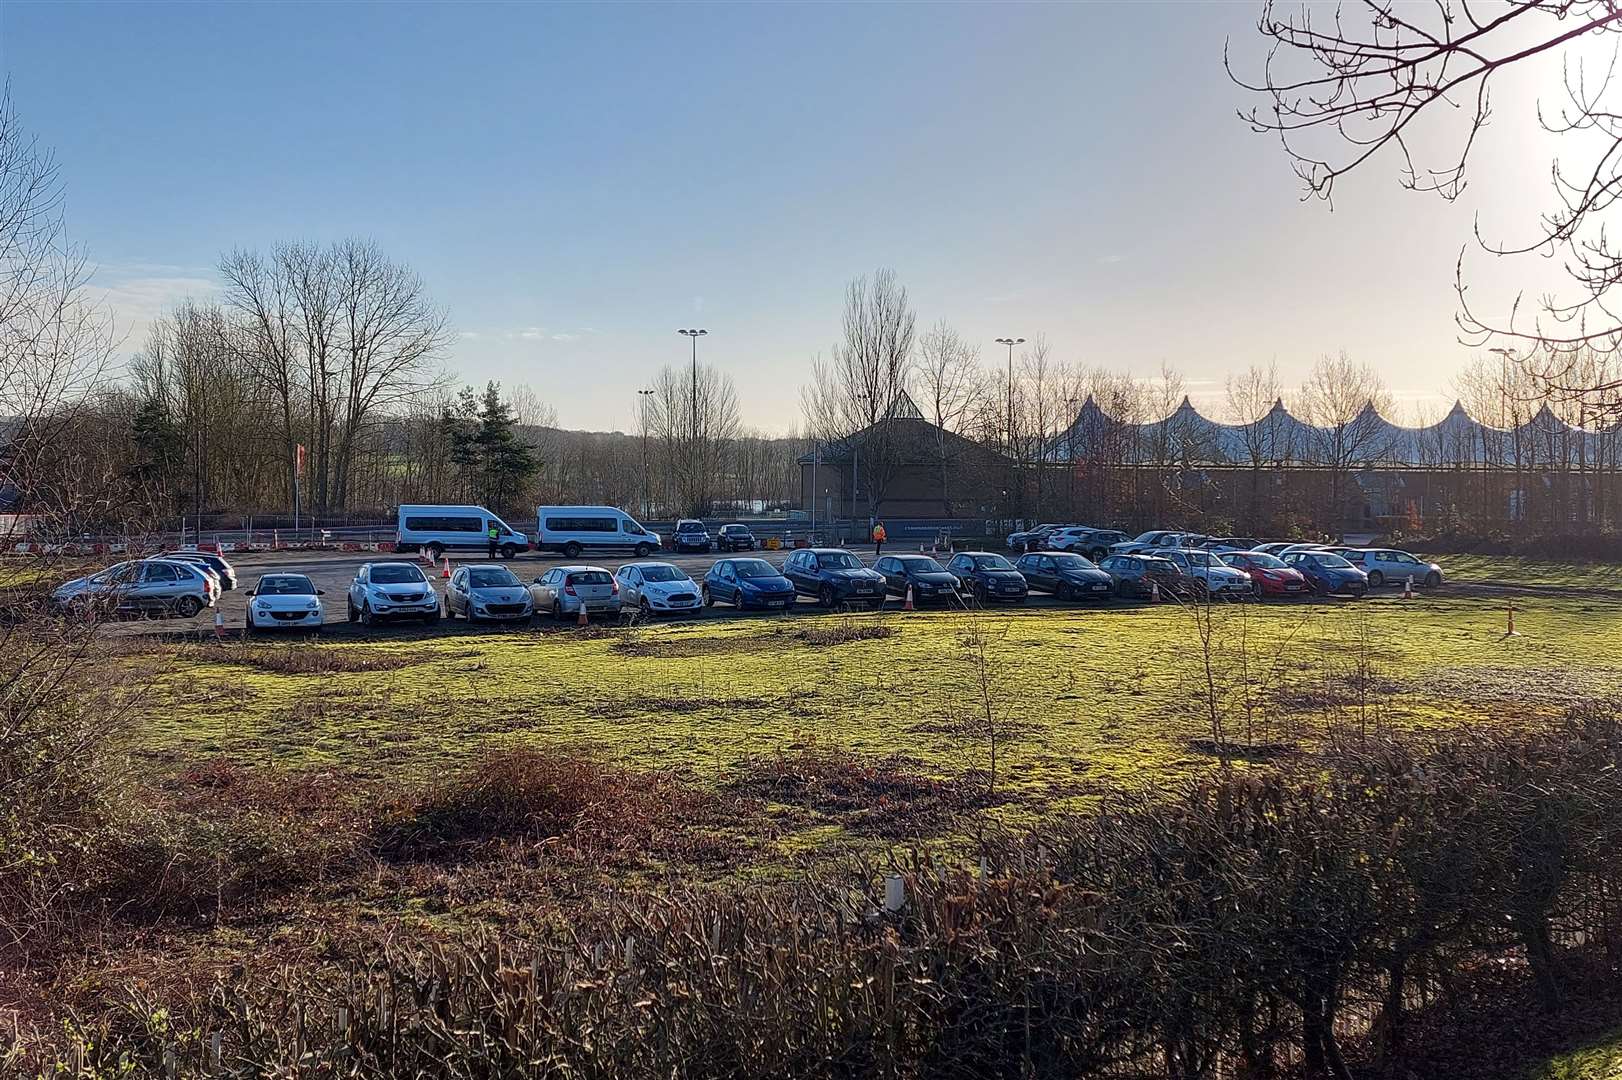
[{"x1": 800, "y1": 269, "x2": 916, "y2": 514}]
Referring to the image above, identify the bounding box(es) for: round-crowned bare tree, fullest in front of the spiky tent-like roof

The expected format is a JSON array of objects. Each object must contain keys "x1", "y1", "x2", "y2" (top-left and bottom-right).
[{"x1": 1299, "y1": 352, "x2": 1392, "y2": 529}]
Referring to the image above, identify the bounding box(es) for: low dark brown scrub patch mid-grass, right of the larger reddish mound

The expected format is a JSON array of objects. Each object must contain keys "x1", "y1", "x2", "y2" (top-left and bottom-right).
[{"x1": 730, "y1": 749, "x2": 996, "y2": 838}]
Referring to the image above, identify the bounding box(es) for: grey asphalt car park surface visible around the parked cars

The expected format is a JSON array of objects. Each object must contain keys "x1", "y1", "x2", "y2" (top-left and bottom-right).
[{"x1": 69, "y1": 548, "x2": 1420, "y2": 636}]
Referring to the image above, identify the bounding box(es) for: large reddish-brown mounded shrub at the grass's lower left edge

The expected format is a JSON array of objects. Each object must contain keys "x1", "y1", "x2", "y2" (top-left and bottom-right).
[{"x1": 376, "y1": 749, "x2": 759, "y2": 864}]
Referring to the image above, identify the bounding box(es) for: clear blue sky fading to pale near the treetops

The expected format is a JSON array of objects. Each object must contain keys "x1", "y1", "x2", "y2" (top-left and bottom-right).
[{"x1": 0, "y1": 0, "x2": 1547, "y2": 430}]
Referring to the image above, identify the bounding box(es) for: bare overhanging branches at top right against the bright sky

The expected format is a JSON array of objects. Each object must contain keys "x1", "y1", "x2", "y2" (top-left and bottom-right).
[{"x1": 1229, "y1": 0, "x2": 1622, "y2": 417}]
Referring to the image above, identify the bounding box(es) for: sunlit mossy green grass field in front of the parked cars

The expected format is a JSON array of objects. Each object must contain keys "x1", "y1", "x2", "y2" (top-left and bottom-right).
[{"x1": 131, "y1": 595, "x2": 1622, "y2": 816}]
